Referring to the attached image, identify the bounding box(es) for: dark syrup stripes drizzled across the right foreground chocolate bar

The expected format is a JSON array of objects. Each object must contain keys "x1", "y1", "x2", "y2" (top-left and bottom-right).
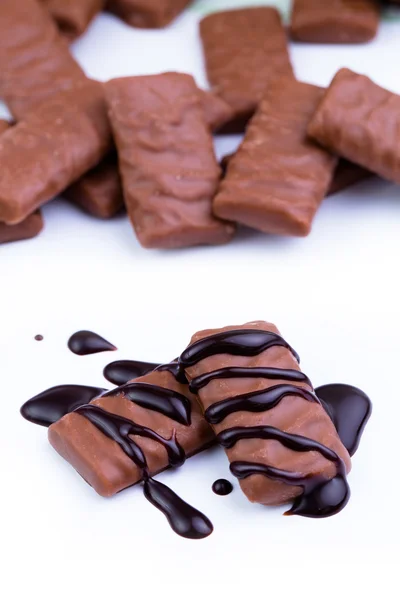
[{"x1": 180, "y1": 329, "x2": 356, "y2": 517}]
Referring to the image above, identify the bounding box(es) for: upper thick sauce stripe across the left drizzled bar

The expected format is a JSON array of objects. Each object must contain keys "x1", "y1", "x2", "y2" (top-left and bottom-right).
[{"x1": 105, "y1": 382, "x2": 192, "y2": 425}]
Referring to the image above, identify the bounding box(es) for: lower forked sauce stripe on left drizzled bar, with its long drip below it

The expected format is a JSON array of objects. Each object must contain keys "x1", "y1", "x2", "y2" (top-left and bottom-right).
[{"x1": 76, "y1": 404, "x2": 213, "y2": 539}]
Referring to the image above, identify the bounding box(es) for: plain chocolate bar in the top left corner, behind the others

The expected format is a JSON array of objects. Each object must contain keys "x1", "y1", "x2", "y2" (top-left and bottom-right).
[{"x1": 0, "y1": 0, "x2": 87, "y2": 120}]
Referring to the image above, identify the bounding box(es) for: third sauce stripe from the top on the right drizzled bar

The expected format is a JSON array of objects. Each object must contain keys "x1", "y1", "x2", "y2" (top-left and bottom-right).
[{"x1": 204, "y1": 385, "x2": 319, "y2": 425}]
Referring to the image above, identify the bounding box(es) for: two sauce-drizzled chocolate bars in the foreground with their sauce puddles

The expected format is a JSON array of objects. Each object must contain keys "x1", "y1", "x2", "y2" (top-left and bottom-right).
[{"x1": 21, "y1": 321, "x2": 371, "y2": 539}]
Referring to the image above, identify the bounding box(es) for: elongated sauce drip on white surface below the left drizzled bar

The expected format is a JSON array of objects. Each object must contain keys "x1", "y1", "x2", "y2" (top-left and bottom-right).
[{"x1": 143, "y1": 477, "x2": 214, "y2": 540}]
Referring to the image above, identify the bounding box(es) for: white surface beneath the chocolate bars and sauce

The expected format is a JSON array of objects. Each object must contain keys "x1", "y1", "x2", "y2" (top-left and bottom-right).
[{"x1": 0, "y1": 2, "x2": 400, "y2": 599}]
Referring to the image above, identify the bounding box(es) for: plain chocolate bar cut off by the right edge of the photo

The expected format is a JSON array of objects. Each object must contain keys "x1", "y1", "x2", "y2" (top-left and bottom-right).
[{"x1": 308, "y1": 69, "x2": 400, "y2": 183}]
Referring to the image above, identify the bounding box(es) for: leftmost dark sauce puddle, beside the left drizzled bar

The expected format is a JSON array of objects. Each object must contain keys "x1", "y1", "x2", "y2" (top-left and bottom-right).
[{"x1": 21, "y1": 385, "x2": 106, "y2": 427}]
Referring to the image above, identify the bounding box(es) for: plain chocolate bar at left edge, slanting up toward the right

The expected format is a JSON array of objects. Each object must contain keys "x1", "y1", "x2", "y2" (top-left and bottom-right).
[{"x1": 0, "y1": 90, "x2": 111, "y2": 225}]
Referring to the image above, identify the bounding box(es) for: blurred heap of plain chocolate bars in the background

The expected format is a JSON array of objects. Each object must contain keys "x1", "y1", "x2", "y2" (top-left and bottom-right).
[{"x1": 0, "y1": 0, "x2": 400, "y2": 248}]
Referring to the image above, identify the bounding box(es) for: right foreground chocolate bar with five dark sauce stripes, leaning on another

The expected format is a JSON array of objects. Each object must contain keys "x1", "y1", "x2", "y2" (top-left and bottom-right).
[{"x1": 179, "y1": 321, "x2": 351, "y2": 517}]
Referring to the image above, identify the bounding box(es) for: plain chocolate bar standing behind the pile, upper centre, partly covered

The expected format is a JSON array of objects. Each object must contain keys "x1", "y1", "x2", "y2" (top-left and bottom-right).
[{"x1": 200, "y1": 7, "x2": 293, "y2": 119}]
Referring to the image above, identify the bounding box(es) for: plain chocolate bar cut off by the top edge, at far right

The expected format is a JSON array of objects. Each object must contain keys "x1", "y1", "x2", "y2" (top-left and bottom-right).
[{"x1": 290, "y1": 0, "x2": 380, "y2": 44}]
